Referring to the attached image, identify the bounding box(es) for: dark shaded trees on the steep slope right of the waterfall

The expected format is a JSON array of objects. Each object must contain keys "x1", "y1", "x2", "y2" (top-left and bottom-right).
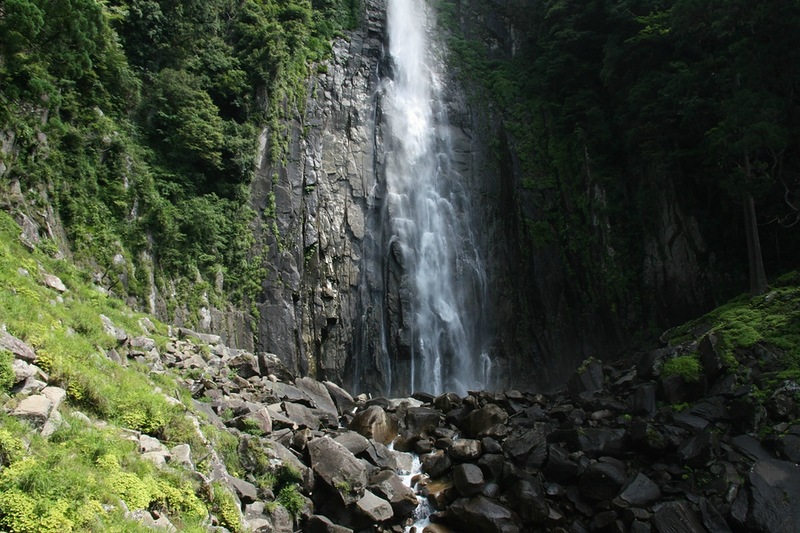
[{"x1": 438, "y1": 0, "x2": 800, "y2": 331}]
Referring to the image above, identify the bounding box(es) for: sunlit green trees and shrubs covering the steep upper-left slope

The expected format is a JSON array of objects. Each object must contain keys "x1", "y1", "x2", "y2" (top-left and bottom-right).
[{"x1": 0, "y1": 0, "x2": 359, "y2": 328}]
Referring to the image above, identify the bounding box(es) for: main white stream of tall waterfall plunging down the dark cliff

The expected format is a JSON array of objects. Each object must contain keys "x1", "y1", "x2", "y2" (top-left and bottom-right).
[{"x1": 368, "y1": 0, "x2": 491, "y2": 394}]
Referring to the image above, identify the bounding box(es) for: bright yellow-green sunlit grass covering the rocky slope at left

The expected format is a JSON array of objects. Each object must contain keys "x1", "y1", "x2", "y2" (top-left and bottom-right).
[{"x1": 0, "y1": 212, "x2": 247, "y2": 533}]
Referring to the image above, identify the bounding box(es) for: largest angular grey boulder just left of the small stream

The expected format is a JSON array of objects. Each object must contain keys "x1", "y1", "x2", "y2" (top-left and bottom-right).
[{"x1": 307, "y1": 437, "x2": 367, "y2": 505}]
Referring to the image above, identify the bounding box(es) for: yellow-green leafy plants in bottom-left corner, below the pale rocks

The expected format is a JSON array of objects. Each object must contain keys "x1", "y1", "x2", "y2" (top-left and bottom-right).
[{"x1": 0, "y1": 415, "x2": 208, "y2": 532}]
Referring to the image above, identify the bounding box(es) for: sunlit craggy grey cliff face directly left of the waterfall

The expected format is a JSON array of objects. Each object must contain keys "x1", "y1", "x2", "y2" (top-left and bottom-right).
[{"x1": 252, "y1": 0, "x2": 385, "y2": 381}]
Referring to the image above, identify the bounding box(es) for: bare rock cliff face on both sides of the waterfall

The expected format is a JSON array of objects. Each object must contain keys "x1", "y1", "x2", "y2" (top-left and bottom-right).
[{"x1": 247, "y1": 0, "x2": 713, "y2": 393}]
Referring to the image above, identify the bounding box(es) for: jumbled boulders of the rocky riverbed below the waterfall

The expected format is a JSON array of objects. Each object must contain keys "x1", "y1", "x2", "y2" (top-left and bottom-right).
[{"x1": 1, "y1": 306, "x2": 800, "y2": 533}]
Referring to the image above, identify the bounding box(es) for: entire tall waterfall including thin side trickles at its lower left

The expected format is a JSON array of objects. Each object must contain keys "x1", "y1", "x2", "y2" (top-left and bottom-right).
[{"x1": 353, "y1": 0, "x2": 492, "y2": 396}]
